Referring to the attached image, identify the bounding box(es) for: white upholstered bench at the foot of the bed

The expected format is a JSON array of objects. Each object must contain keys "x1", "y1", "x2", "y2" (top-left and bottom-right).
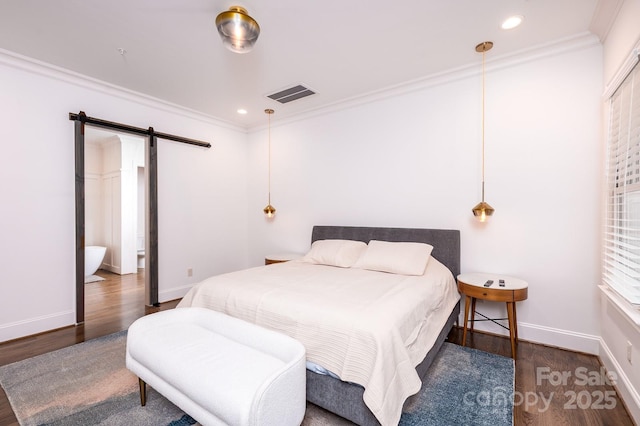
[{"x1": 126, "y1": 308, "x2": 306, "y2": 426}]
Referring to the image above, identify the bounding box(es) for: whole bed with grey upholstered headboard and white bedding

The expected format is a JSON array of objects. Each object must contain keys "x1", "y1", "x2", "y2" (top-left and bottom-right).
[{"x1": 178, "y1": 226, "x2": 460, "y2": 426}]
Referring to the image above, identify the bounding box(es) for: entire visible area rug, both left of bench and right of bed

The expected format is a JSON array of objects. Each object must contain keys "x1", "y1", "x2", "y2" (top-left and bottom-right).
[{"x1": 0, "y1": 332, "x2": 514, "y2": 426}]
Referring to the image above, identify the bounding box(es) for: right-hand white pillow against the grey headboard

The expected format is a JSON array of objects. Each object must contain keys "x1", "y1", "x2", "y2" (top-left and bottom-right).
[{"x1": 353, "y1": 240, "x2": 433, "y2": 275}]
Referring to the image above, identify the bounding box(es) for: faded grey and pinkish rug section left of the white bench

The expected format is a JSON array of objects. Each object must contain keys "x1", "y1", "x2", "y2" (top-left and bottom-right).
[{"x1": 0, "y1": 331, "x2": 195, "y2": 426}]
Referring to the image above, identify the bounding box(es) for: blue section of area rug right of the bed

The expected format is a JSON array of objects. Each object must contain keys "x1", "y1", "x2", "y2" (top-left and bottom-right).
[{"x1": 400, "y1": 342, "x2": 515, "y2": 426}]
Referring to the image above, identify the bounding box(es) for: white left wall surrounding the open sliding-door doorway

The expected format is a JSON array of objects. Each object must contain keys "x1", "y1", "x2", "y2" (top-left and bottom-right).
[{"x1": 0, "y1": 52, "x2": 247, "y2": 341}]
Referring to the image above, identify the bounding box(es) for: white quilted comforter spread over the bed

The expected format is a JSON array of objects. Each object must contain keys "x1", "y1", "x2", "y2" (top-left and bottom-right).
[{"x1": 178, "y1": 258, "x2": 460, "y2": 426}]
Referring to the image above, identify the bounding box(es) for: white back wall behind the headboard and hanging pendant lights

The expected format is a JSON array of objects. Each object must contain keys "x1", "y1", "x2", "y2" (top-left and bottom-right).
[{"x1": 248, "y1": 37, "x2": 602, "y2": 353}]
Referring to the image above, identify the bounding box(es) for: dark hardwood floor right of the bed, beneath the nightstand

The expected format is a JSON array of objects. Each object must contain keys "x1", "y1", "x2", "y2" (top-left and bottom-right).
[{"x1": 448, "y1": 328, "x2": 635, "y2": 426}]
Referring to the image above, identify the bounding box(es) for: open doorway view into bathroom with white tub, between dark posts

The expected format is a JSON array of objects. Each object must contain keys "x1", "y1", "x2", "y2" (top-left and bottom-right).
[{"x1": 84, "y1": 126, "x2": 146, "y2": 318}]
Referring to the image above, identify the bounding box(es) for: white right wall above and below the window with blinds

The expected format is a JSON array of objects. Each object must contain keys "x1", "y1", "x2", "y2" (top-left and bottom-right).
[{"x1": 599, "y1": 0, "x2": 640, "y2": 423}]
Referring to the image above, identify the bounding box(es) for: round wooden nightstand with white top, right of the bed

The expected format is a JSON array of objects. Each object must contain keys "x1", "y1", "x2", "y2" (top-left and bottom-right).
[{"x1": 458, "y1": 273, "x2": 529, "y2": 359}]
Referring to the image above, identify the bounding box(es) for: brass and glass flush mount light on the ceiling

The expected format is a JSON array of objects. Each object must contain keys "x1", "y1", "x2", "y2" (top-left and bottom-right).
[{"x1": 216, "y1": 6, "x2": 260, "y2": 53}]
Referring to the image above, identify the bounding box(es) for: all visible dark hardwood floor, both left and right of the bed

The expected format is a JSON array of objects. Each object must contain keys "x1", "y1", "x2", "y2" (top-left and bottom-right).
[{"x1": 0, "y1": 271, "x2": 634, "y2": 426}]
